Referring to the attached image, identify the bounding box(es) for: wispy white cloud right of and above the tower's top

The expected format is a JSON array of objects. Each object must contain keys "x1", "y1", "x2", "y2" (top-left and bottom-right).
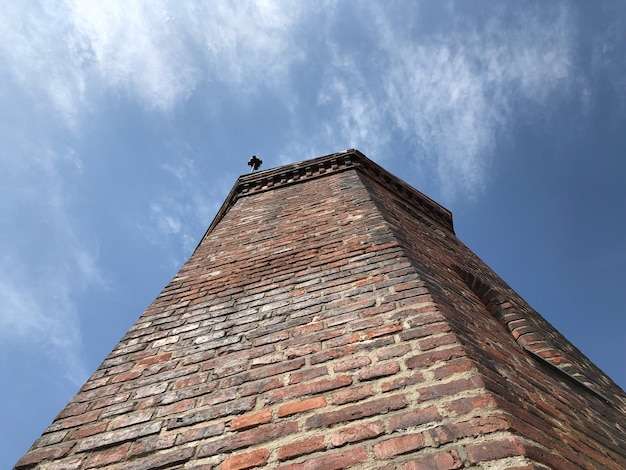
[{"x1": 292, "y1": 4, "x2": 581, "y2": 199}]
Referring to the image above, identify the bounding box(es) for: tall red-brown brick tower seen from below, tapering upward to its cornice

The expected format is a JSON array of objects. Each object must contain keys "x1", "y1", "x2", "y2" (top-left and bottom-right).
[{"x1": 16, "y1": 150, "x2": 626, "y2": 470}]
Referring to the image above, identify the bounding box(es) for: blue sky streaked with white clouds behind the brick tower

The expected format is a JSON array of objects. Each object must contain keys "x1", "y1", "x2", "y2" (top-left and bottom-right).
[{"x1": 0, "y1": 0, "x2": 626, "y2": 468}]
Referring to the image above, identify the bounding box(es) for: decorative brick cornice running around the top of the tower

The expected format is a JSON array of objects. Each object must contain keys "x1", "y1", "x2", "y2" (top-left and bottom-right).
[{"x1": 203, "y1": 149, "x2": 454, "y2": 246}]
